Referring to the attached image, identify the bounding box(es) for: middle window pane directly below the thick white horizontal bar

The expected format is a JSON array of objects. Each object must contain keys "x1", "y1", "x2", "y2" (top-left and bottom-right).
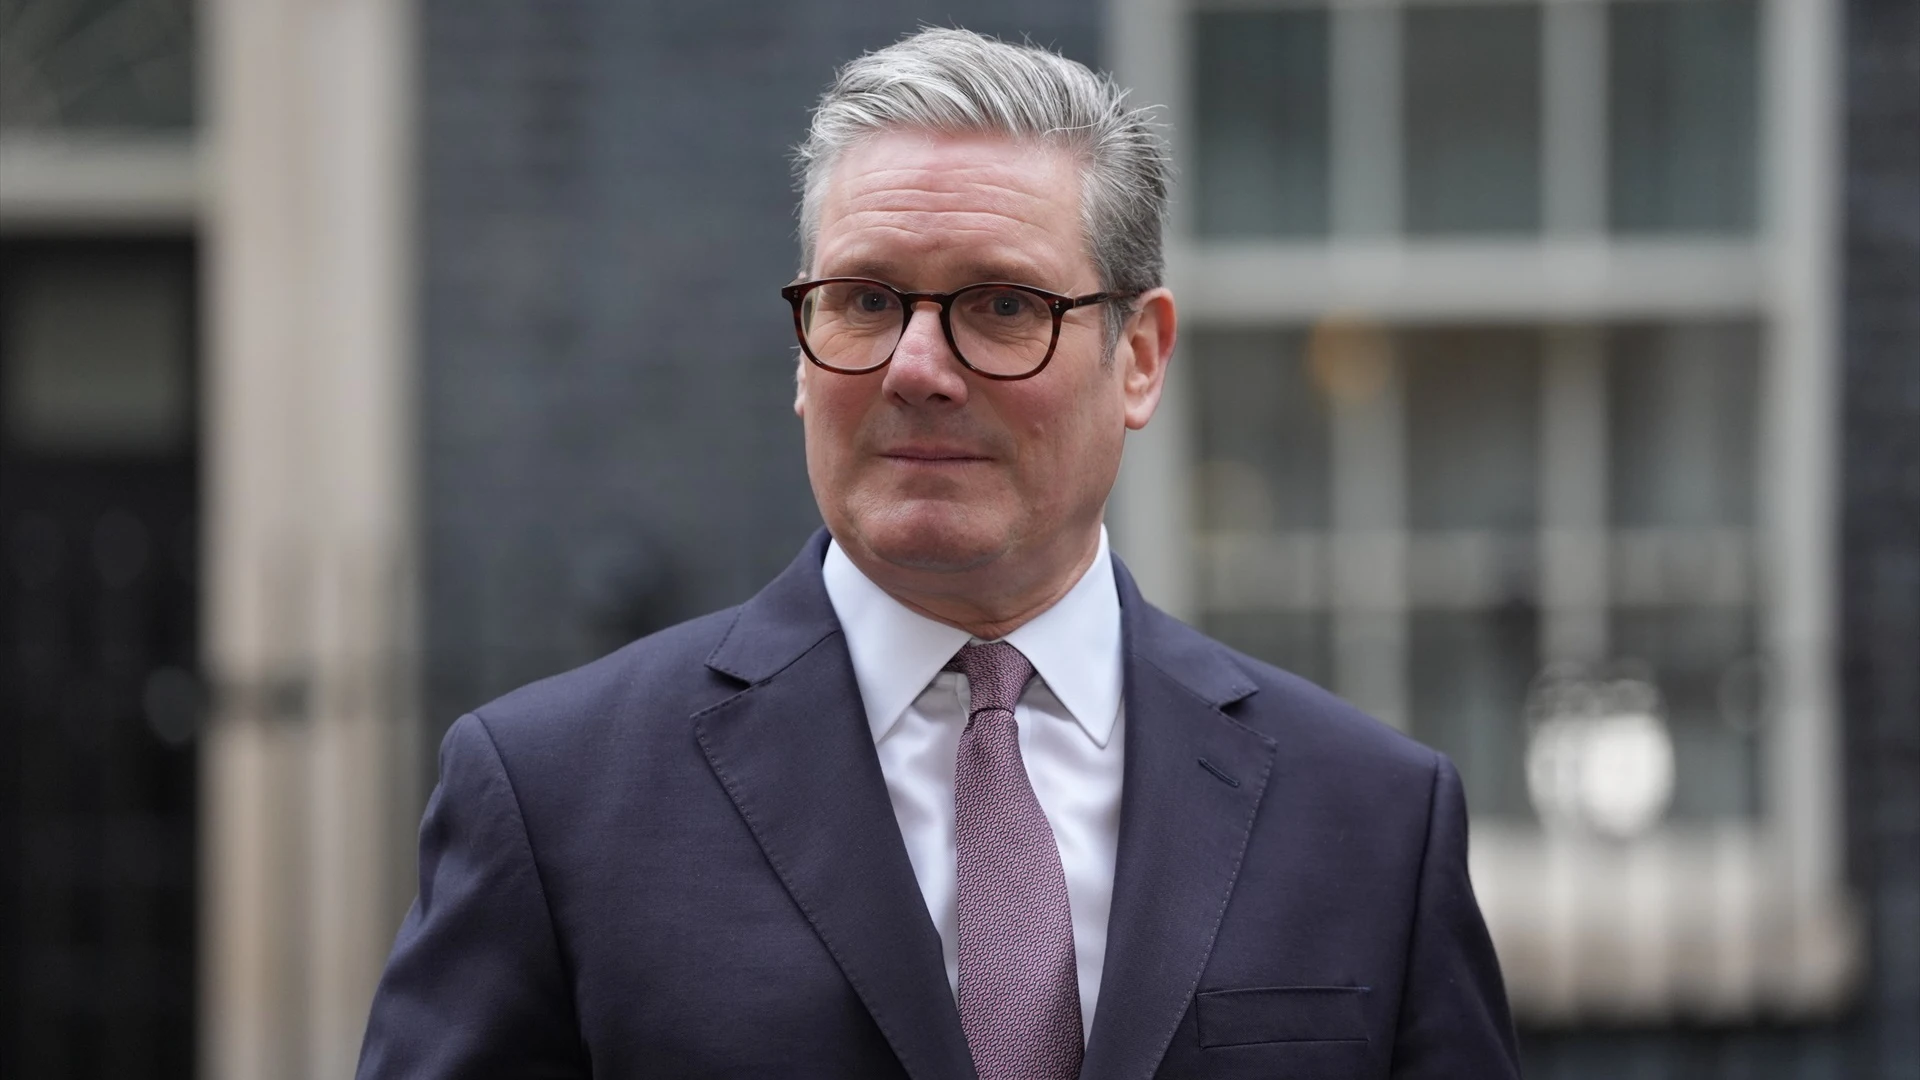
[{"x1": 1402, "y1": 329, "x2": 1540, "y2": 530}]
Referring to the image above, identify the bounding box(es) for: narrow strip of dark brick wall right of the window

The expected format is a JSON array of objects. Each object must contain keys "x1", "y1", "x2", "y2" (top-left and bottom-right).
[{"x1": 1839, "y1": 0, "x2": 1920, "y2": 1078}]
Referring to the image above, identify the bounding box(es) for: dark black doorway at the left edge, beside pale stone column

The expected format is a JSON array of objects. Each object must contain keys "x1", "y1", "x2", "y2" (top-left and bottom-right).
[{"x1": 0, "y1": 236, "x2": 202, "y2": 1078}]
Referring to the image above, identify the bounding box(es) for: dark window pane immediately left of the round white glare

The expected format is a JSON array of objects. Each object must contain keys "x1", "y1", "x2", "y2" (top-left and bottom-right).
[{"x1": 1407, "y1": 603, "x2": 1540, "y2": 817}]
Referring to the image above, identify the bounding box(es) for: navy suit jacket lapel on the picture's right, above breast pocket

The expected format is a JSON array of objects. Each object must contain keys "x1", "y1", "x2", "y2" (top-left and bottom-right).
[{"x1": 1081, "y1": 559, "x2": 1275, "y2": 1080}]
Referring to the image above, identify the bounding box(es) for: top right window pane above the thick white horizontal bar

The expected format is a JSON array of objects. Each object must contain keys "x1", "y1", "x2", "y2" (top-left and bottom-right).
[{"x1": 1607, "y1": 0, "x2": 1759, "y2": 233}]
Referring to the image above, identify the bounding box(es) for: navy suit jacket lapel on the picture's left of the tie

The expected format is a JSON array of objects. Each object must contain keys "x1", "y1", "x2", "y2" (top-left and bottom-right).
[{"x1": 695, "y1": 530, "x2": 973, "y2": 1080}]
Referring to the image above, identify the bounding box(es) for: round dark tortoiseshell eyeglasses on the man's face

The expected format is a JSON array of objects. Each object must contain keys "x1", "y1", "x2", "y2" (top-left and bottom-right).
[{"x1": 780, "y1": 277, "x2": 1123, "y2": 380}]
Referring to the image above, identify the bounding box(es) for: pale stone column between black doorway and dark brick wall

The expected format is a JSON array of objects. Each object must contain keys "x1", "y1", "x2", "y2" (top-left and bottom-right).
[{"x1": 202, "y1": 0, "x2": 420, "y2": 1080}]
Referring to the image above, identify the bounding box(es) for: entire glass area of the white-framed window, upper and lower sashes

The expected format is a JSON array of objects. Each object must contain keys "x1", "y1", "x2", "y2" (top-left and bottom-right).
[{"x1": 1188, "y1": 0, "x2": 1780, "y2": 849}]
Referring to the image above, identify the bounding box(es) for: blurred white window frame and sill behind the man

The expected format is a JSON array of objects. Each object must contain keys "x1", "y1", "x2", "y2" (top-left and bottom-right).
[{"x1": 1106, "y1": 0, "x2": 1860, "y2": 1024}]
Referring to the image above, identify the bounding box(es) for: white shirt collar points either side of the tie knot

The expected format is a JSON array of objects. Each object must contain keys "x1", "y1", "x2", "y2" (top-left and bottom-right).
[{"x1": 820, "y1": 527, "x2": 1123, "y2": 748}]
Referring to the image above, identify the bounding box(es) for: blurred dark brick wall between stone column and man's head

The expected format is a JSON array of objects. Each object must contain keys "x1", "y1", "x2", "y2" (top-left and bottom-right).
[{"x1": 419, "y1": 0, "x2": 1100, "y2": 736}]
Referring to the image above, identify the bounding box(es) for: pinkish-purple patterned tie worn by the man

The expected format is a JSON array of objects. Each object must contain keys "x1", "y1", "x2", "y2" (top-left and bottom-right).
[{"x1": 947, "y1": 642, "x2": 1081, "y2": 1080}]
